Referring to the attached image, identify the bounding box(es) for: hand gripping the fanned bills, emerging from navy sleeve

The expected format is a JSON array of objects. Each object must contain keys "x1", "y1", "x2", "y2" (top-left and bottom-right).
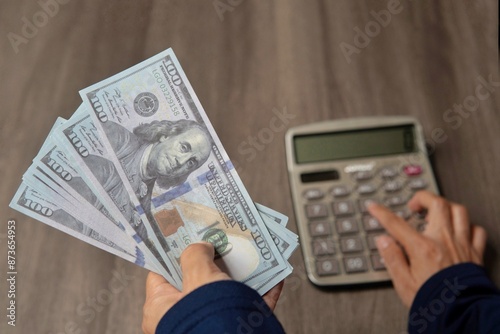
[{"x1": 142, "y1": 242, "x2": 283, "y2": 334}]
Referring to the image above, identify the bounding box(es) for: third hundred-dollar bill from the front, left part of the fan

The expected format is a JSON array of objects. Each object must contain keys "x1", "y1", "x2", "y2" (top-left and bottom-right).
[{"x1": 30, "y1": 118, "x2": 165, "y2": 272}]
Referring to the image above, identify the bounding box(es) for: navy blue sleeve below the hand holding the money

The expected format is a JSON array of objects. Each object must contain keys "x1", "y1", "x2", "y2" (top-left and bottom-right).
[{"x1": 156, "y1": 281, "x2": 284, "y2": 334}]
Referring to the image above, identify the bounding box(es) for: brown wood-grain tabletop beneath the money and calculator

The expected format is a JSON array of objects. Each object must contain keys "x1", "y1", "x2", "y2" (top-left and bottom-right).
[{"x1": 0, "y1": 0, "x2": 500, "y2": 334}]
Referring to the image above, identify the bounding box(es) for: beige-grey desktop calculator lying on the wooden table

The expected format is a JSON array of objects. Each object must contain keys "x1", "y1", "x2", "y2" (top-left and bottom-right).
[{"x1": 285, "y1": 116, "x2": 438, "y2": 286}]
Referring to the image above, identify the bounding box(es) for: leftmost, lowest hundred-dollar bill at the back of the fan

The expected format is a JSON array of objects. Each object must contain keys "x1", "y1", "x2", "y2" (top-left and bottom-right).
[{"x1": 10, "y1": 182, "x2": 143, "y2": 266}]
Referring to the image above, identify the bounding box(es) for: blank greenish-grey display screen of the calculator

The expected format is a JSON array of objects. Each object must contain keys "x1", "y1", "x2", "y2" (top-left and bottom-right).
[{"x1": 293, "y1": 125, "x2": 417, "y2": 164}]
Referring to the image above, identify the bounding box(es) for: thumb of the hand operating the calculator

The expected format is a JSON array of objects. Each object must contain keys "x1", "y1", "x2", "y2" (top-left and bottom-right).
[{"x1": 376, "y1": 235, "x2": 416, "y2": 307}]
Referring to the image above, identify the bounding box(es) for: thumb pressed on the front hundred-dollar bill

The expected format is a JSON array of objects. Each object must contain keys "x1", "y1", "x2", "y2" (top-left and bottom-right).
[{"x1": 180, "y1": 242, "x2": 231, "y2": 293}]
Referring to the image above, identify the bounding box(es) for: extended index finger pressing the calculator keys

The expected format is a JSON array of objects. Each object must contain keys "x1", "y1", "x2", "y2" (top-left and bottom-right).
[{"x1": 368, "y1": 203, "x2": 422, "y2": 253}]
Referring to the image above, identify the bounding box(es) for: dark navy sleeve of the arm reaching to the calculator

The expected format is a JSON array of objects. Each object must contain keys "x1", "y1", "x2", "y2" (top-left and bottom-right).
[{"x1": 408, "y1": 263, "x2": 500, "y2": 334}]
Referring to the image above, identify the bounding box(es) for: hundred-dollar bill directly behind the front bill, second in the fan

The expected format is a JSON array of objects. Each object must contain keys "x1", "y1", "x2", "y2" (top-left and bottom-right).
[{"x1": 53, "y1": 105, "x2": 181, "y2": 287}]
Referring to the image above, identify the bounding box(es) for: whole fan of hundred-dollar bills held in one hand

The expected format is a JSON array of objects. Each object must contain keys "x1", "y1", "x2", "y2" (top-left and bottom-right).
[{"x1": 10, "y1": 49, "x2": 298, "y2": 294}]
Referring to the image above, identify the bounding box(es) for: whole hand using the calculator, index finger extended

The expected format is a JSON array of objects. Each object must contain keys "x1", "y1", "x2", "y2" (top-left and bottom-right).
[{"x1": 368, "y1": 191, "x2": 486, "y2": 307}]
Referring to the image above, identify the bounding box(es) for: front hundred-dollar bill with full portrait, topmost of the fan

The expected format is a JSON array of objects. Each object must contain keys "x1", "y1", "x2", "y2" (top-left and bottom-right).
[{"x1": 78, "y1": 49, "x2": 287, "y2": 286}]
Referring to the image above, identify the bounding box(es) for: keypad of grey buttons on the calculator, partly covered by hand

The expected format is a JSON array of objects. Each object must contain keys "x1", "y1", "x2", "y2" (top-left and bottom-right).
[{"x1": 303, "y1": 164, "x2": 428, "y2": 277}]
